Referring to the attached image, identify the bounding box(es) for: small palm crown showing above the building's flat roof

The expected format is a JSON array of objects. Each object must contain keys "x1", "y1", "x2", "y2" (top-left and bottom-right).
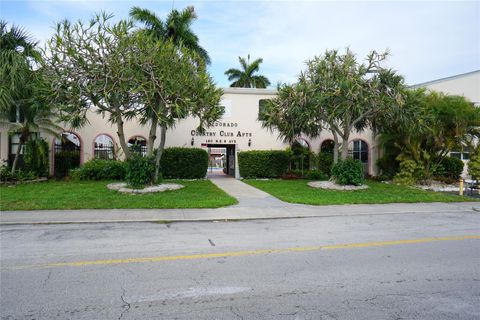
[{"x1": 225, "y1": 55, "x2": 270, "y2": 88}]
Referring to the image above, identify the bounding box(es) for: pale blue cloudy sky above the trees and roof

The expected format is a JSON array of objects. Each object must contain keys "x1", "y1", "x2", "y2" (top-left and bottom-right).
[{"x1": 0, "y1": 0, "x2": 480, "y2": 87}]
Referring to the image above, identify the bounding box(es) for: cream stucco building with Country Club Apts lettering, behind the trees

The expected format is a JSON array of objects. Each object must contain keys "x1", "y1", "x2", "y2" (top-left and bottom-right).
[{"x1": 0, "y1": 70, "x2": 480, "y2": 178}]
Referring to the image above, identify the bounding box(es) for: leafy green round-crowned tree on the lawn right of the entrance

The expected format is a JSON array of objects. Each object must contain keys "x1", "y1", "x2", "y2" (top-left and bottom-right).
[{"x1": 299, "y1": 49, "x2": 405, "y2": 162}]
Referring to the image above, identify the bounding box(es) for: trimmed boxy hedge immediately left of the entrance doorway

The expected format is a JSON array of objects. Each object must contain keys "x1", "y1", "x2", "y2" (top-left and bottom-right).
[{"x1": 160, "y1": 148, "x2": 208, "y2": 179}]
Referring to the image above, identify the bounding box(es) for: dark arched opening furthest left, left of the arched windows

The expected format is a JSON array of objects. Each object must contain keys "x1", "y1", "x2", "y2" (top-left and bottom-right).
[{"x1": 53, "y1": 132, "x2": 82, "y2": 178}]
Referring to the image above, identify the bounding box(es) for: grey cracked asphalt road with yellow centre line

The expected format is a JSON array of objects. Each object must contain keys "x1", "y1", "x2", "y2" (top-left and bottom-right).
[{"x1": 0, "y1": 211, "x2": 480, "y2": 320}]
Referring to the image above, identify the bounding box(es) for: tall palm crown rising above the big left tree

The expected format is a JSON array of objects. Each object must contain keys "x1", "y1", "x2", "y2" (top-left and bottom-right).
[{"x1": 130, "y1": 6, "x2": 211, "y2": 64}]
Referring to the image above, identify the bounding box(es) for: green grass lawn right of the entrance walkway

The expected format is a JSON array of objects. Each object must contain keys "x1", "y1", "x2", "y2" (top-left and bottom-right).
[{"x1": 244, "y1": 180, "x2": 475, "y2": 205}]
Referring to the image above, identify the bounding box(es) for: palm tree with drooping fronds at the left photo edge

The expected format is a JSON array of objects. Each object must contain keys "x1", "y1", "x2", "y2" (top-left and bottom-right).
[{"x1": 0, "y1": 21, "x2": 61, "y2": 173}]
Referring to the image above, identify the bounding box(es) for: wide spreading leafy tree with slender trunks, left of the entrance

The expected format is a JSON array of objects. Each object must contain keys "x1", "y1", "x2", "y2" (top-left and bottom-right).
[{"x1": 43, "y1": 14, "x2": 223, "y2": 181}]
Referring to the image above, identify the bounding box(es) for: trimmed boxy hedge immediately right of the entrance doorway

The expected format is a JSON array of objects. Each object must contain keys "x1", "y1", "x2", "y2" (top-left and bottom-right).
[{"x1": 238, "y1": 150, "x2": 289, "y2": 178}]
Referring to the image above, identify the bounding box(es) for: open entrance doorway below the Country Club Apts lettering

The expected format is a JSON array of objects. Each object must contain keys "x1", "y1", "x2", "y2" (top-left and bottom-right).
[{"x1": 206, "y1": 144, "x2": 235, "y2": 177}]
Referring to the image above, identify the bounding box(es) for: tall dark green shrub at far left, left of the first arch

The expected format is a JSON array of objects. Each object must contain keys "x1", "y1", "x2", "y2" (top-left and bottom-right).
[{"x1": 23, "y1": 139, "x2": 49, "y2": 177}]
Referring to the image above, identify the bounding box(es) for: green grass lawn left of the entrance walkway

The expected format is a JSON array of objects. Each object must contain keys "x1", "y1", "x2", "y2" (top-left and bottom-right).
[{"x1": 0, "y1": 180, "x2": 237, "y2": 210}]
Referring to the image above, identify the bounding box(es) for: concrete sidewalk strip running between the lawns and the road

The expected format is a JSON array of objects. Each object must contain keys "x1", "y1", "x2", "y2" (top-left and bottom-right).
[{"x1": 0, "y1": 202, "x2": 480, "y2": 225}]
